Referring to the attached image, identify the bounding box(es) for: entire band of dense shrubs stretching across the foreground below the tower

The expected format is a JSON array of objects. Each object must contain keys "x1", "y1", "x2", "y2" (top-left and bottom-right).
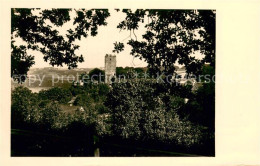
[{"x1": 12, "y1": 79, "x2": 214, "y2": 152}]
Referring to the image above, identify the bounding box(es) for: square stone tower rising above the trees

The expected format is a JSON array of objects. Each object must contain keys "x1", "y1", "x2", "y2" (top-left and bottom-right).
[{"x1": 105, "y1": 54, "x2": 116, "y2": 84}]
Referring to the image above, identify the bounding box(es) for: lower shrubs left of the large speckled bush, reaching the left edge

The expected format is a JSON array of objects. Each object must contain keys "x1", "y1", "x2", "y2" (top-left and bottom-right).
[{"x1": 12, "y1": 85, "x2": 109, "y2": 136}]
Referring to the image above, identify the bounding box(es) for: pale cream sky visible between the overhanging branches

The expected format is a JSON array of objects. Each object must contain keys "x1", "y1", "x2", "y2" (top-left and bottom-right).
[{"x1": 31, "y1": 10, "x2": 147, "y2": 68}]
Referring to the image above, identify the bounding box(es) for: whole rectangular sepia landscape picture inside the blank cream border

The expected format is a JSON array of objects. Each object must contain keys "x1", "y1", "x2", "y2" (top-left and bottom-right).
[{"x1": 11, "y1": 8, "x2": 216, "y2": 157}]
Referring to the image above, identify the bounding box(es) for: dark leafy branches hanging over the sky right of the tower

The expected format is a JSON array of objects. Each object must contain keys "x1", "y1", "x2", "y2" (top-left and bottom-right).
[{"x1": 114, "y1": 9, "x2": 215, "y2": 74}]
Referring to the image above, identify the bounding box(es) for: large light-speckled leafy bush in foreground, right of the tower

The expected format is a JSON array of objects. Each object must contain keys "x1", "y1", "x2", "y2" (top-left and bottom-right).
[{"x1": 105, "y1": 80, "x2": 206, "y2": 146}]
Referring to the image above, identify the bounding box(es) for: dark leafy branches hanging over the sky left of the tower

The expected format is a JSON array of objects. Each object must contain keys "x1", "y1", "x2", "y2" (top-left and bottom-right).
[{"x1": 11, "y1": 8, "x2": 110, "y2": 82}]
